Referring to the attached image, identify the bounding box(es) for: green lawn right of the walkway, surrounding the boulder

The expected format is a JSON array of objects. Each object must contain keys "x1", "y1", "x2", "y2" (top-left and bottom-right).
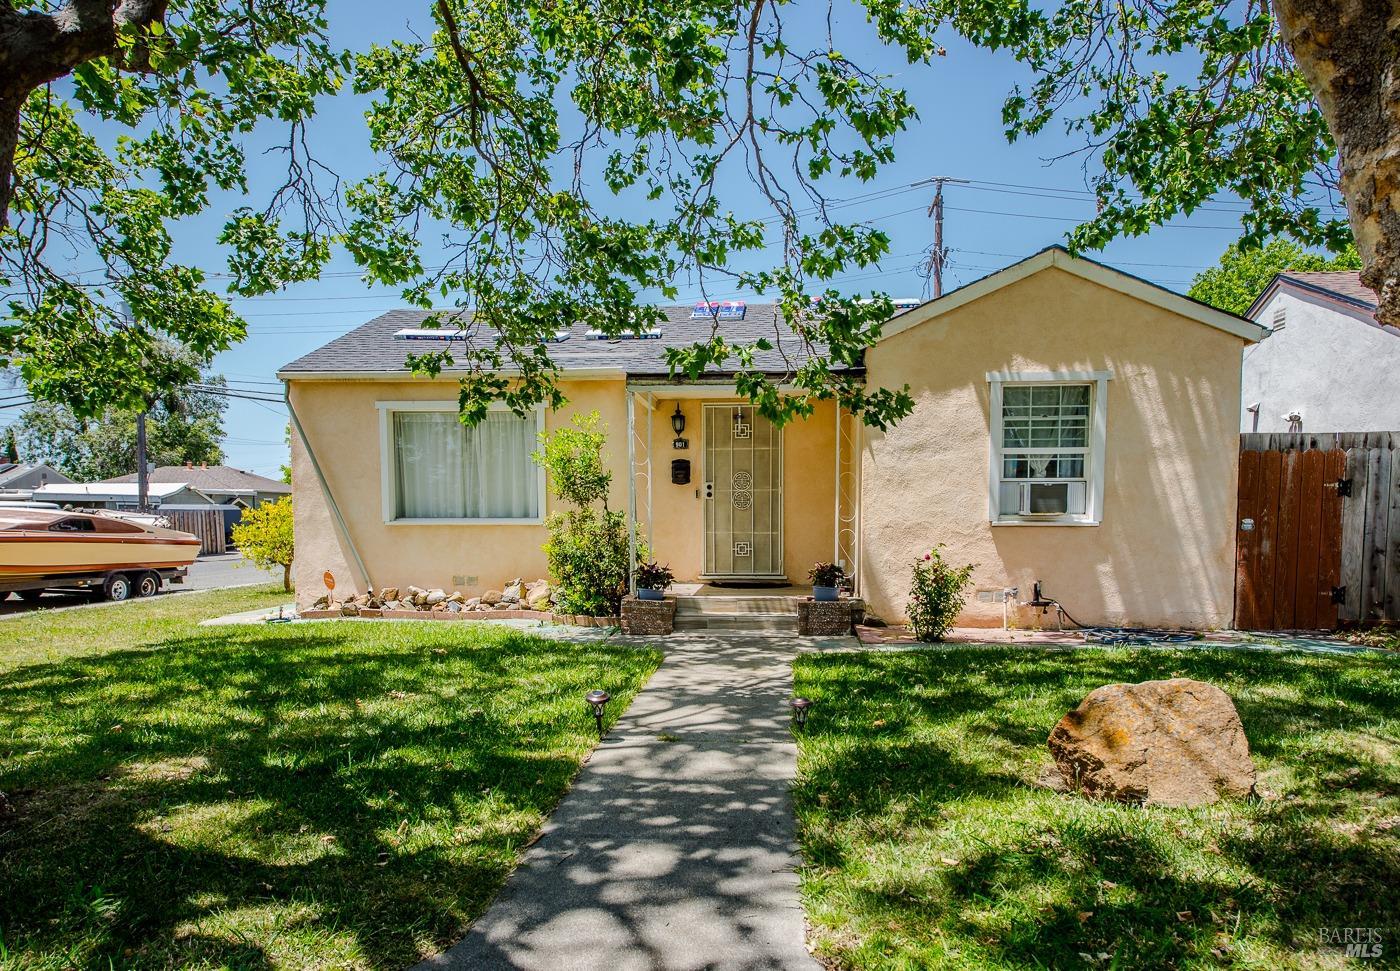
[{"x1": 794, "y1": 648, "x2": 1400, "y2": 971}]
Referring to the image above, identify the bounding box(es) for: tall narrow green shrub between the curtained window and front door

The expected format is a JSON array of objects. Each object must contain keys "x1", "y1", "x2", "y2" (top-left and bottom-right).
[{"x1": 533, "y1": 411, "x2": 647, "y2": 616}]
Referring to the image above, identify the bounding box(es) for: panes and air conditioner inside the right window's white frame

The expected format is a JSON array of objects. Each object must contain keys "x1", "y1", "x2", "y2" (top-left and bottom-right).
[{"x1": 997, "y1": 382, "x2": 1093, "y2": 518}]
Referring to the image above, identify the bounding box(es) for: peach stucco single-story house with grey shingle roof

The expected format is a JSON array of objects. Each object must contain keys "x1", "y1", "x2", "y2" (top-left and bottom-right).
[{"x1": 279, "y1": 248, "x2": 1264, "y2": 627}]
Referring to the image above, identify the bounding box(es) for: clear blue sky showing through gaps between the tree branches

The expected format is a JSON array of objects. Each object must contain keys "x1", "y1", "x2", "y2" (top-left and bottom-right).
[{"x1": 10, "y1": 0, "x2": 1282, "y2": 476}]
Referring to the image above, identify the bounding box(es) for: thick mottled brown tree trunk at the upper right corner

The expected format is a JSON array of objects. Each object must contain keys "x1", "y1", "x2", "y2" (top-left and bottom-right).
[{"x1": 1274, "y1": 0, "x2": 1400, "y2": 327}]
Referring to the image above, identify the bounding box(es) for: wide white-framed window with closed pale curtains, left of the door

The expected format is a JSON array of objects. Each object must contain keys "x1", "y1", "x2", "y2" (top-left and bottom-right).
[{"x1": 377, "y1": 402, "x2": 545, "y2": 525}]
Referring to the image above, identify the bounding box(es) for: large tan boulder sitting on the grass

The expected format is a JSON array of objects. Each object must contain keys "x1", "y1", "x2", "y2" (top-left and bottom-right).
[{"x1": 1050, "y1": 677, "x2": 1254, "y2": 806}]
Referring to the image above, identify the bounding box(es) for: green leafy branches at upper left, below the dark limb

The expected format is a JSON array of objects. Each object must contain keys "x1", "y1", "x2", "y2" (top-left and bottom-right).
[{"x1": 0, "y1": 0, "x2": 346, "y2": 417}]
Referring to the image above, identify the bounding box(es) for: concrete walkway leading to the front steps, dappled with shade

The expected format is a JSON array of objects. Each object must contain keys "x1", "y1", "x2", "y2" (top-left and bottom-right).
[{"x1": 420, "y1": 631, "x2": 819, "y2": 971}]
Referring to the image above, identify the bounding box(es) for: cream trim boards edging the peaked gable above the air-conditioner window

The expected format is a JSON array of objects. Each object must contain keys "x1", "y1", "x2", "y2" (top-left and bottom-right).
[{"x1": 881, "y1": 246, "x2": 1268, "y2": 343}]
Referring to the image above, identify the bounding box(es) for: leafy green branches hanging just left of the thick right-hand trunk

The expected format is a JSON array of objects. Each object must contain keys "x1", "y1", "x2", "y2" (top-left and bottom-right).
[{"x1": 985, "y1": 0, "x2": 1350, "y2": 252}]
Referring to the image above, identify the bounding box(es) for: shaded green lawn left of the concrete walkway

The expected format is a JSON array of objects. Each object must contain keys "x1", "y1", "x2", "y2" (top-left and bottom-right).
[{"x1": 0, "y1": 590, "x2": 659, "y2": 968}]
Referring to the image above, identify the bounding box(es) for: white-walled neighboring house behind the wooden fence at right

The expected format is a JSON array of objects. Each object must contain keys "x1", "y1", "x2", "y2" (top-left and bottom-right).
[{"x1": 1240, "y1": 270, "x2": 1400, "y2": 432}]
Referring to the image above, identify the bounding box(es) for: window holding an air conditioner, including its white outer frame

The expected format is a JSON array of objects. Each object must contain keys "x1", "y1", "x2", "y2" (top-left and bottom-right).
[{"x1": 987, "y1": 371, "x2": 1113, "y2": 526}]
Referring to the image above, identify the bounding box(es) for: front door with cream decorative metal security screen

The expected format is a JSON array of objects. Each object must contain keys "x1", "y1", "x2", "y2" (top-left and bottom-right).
[{"x1": 703, "y1": 404, "x2": 783, "y2": 579}]
